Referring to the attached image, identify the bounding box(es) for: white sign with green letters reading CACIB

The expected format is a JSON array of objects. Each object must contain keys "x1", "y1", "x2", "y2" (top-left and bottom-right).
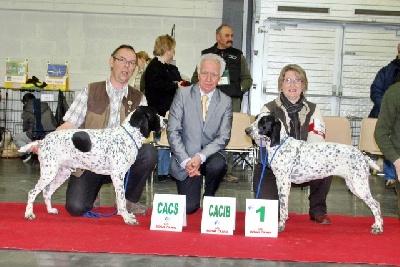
[{"x1": 201, "y1": 197, "x2": 236, "y2": 235}]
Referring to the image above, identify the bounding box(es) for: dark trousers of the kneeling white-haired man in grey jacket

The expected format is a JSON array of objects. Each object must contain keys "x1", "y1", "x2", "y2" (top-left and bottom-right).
[{"x1": 176, "y1": 153, "x2": 227, "y2": 214}]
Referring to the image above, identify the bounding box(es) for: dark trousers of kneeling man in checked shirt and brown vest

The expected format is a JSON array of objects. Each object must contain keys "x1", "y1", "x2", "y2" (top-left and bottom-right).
[{"x1": 65, "y1": 144, "x2": 157, "y2": 216}]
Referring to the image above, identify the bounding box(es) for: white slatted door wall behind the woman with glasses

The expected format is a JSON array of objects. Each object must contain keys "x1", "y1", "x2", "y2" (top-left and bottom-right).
[{"x1": 251, "y1": 0, "x2": 400, "y2": 117}]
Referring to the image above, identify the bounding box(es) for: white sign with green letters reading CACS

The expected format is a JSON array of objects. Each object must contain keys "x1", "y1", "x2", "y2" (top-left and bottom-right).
[{"x1": 150, "y1": 194, "x2": 186, "y2": 232}]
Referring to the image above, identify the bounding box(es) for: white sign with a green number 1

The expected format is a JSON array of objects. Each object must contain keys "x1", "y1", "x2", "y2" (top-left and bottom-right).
[{"x1": 245, "y1": 199, "x2": 278, "y2": 237}]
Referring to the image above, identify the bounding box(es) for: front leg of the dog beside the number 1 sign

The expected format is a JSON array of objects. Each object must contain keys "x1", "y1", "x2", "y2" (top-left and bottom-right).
[{"x1": 275, "y1": 173, "x2": 291, "y2": 232}]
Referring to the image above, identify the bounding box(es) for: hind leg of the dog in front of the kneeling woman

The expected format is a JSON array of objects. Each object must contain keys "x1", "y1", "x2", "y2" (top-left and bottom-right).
[{"x1": 346, "y1": 174, "x2": 383, "y2": 234}]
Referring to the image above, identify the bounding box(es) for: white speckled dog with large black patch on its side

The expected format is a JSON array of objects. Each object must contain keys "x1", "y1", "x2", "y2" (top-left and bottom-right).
[{"x1": 21, "y1": 106, "x2": 164, "y2": 225}]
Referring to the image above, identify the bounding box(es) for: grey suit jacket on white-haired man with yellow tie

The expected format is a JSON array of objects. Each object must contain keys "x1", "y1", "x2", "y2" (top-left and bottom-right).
[{"x1": 167, "y1": 84, "x2": 232, "y2": 181}]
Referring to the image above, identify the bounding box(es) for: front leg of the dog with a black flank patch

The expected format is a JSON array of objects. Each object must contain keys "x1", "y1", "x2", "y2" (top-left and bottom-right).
[{"x1": 111, "y1": 172, "x2": 139, "y2": 225}]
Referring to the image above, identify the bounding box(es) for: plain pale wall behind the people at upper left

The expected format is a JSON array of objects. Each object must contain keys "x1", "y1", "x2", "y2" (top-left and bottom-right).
[{"x1": 0, "y1": 0, "x2": 222, "y2": 89}]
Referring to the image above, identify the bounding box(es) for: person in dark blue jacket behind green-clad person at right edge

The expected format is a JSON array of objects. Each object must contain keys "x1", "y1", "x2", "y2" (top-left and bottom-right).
[{"x1": 368, "y1": 43, "x2": 400, "y2": 189}]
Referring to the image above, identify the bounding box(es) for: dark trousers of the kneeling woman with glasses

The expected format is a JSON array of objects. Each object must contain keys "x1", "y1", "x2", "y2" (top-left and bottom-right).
[{"x1": 253, "y1": 163, "x2": 332, "y2": 216}]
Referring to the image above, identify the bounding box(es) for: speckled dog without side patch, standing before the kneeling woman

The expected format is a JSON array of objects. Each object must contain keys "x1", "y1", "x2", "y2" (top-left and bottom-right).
[{"x1": 245, "y1": 113, "x2": 383, "y2": 234}]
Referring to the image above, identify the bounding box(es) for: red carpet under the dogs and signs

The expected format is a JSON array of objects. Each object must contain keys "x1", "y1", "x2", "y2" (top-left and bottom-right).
[{"x1": 0, "y1": 203, "x2": 400, "y2": 266}]
